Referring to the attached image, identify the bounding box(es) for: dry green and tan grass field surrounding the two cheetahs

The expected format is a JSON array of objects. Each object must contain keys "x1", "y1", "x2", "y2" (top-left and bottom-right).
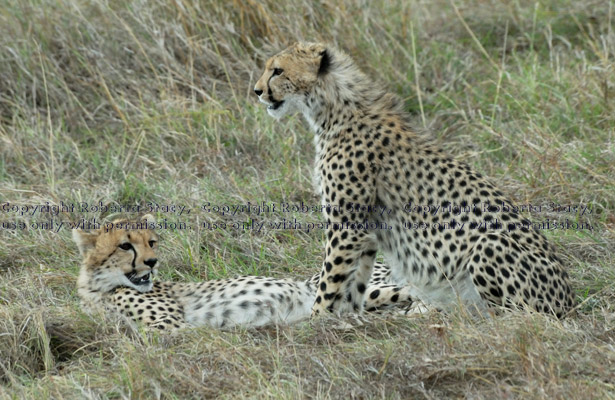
[{"x1": 0, "y1": 0, "x2": 615, "y2": 399}]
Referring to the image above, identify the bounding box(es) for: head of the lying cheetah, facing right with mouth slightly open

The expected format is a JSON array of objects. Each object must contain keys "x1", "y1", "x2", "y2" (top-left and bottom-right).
[{"x1": 73, "y1": 215, "x2": 158, "y2": 297}]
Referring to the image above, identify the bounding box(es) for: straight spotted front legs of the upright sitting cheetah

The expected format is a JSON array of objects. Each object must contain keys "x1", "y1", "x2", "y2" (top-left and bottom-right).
[{"x1": 312, "y1": 145, "x2": 378, "y2": 316}]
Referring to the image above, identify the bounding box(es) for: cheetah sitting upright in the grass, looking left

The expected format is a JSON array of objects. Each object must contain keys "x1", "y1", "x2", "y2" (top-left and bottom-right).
[{"x1": 254, "y1": 43, "x2": 574, "y2": 317}]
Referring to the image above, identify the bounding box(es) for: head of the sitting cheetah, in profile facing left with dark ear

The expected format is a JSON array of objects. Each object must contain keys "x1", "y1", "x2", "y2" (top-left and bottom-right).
[{"x1": 254, "y1": 43, "x2": 331, "y2": 118}]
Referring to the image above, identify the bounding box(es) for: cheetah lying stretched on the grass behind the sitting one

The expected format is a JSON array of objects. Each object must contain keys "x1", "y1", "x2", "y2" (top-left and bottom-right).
[{"x1": 73, "y1": 215, "x2": 411, "y2": 330}]
